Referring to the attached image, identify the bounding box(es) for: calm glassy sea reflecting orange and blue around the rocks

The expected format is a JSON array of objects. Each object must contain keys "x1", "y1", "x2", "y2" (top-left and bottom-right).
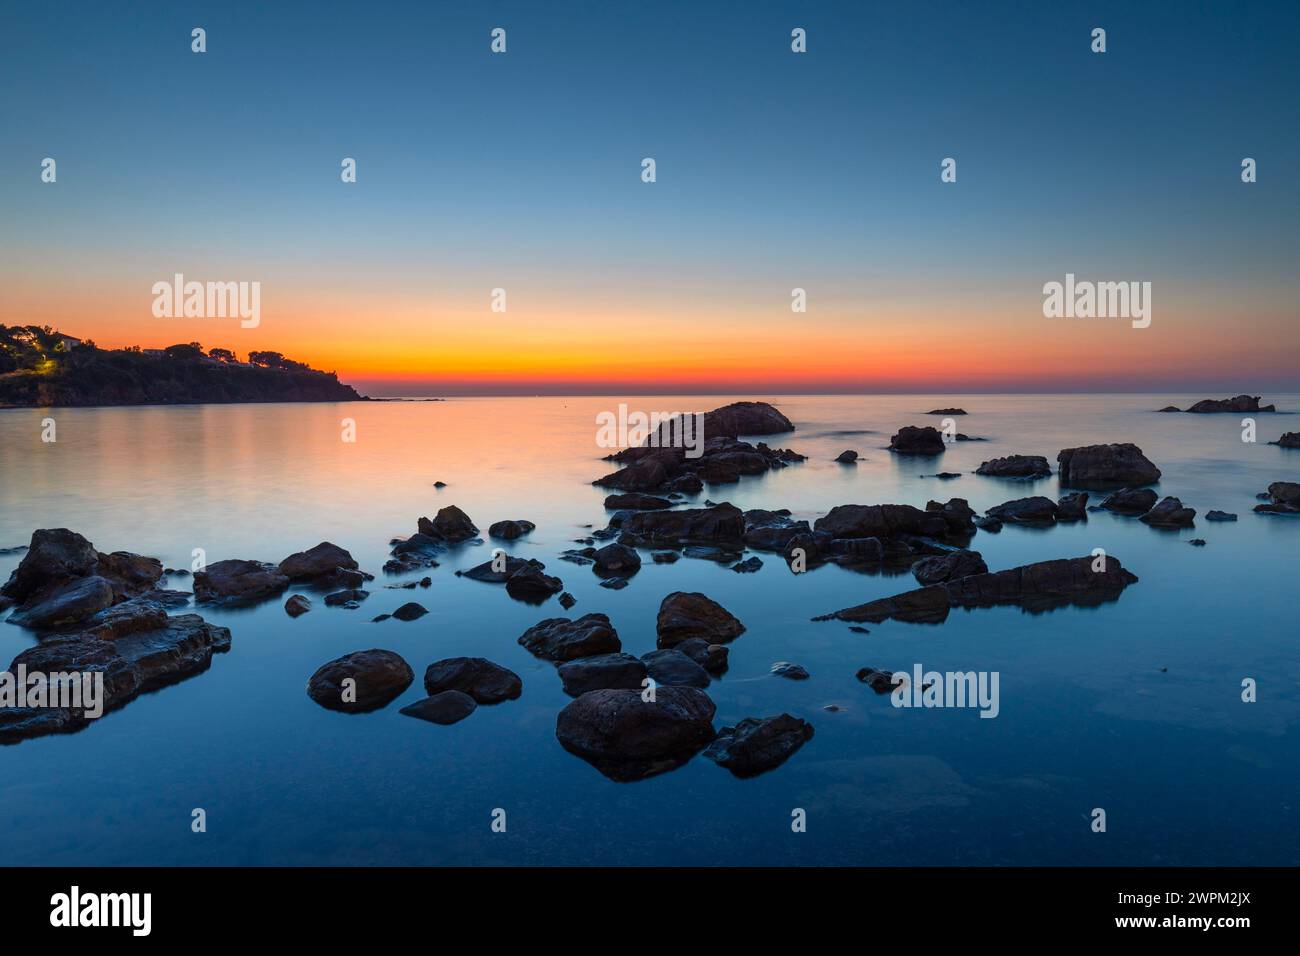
[{"x1": 0, "y1": 395, "x2": 1300, "y2": 865}]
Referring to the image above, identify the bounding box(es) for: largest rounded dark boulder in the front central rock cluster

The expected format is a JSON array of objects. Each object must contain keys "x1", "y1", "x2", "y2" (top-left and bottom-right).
[{"x1": 555, "y1": 687, "x2": 716, "y2": 780}]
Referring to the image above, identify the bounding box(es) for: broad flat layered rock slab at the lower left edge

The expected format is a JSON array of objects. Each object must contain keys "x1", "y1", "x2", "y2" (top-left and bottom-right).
[{"x1": 0, "y1": 614, "x2": 230, "y2": 744}]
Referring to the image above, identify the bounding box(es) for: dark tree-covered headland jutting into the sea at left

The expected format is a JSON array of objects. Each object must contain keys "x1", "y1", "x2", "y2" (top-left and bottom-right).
[{"x1": 0, "y1": 325, "x2": 371, "y2": 408}]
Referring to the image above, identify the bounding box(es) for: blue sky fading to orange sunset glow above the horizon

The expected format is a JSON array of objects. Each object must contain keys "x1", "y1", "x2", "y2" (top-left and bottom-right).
[{"x1": 0, "y1": 0, "x2": 1300, "y2": 395}]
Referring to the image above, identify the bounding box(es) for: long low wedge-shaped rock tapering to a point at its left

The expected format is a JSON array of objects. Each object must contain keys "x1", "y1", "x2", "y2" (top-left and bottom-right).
[{"x1": 814, "y1": 555, "x2": 1138, "y2": 624}]
